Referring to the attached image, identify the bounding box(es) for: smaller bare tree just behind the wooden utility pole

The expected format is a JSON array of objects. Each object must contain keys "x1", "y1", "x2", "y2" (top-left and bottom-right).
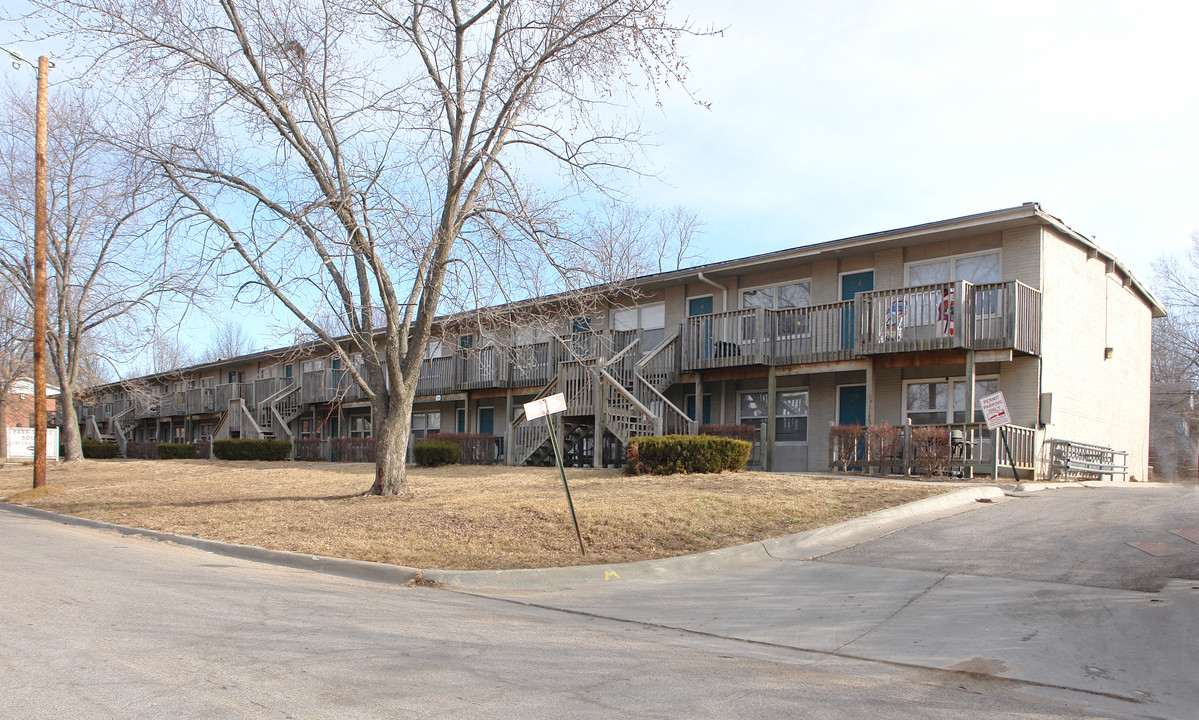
[{"x1": 0, "y1": 84, "x2": 194, "y2": 461}]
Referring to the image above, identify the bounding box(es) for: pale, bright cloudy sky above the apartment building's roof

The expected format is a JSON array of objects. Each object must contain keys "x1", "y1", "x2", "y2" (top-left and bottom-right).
[{"x1": 0, "y1": 0, "x2": 1199, "y2": 364}]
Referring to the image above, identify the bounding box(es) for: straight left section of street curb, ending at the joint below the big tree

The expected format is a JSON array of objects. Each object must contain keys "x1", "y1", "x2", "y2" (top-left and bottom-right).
[{"x1": 0, "y1": 503, "x2": 421, "y2": 585}]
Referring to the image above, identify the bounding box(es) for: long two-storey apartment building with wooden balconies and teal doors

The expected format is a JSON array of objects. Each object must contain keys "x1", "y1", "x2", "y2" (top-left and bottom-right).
[{"x1": 72, "y1": 204, "x2": 1164, "y2": 479}]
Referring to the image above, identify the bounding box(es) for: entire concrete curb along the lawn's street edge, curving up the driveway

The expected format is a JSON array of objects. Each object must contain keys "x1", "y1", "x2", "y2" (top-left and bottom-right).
[{"x1": 0, "y1": 486, "x2": 1004, "y2": 591}]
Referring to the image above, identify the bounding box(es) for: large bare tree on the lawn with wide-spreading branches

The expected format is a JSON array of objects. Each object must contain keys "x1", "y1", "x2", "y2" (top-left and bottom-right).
[{"x1": 34, "y1": 0, "x2": 705, "y2": 495}]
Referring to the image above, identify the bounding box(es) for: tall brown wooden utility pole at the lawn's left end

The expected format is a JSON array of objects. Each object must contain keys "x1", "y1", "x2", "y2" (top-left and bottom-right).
[{"x1": 34, "y1": 55, "x2": 50, "y2": 488}]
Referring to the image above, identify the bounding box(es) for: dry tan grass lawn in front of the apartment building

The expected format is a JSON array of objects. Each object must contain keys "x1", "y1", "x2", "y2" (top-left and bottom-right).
[{"x1": 0, "y1": 460, "x2": 950, "y2": 569}]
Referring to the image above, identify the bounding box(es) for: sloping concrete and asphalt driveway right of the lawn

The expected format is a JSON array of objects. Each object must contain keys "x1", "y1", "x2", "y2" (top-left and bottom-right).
[{"x1": 481, "y1": 486, "x2": 1199, "y2": 719}]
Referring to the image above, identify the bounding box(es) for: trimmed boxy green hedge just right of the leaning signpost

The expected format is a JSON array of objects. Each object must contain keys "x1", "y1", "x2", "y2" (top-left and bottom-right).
[{"x1": 625, "y1": 435, "x2": 751, "y2": 474}]
